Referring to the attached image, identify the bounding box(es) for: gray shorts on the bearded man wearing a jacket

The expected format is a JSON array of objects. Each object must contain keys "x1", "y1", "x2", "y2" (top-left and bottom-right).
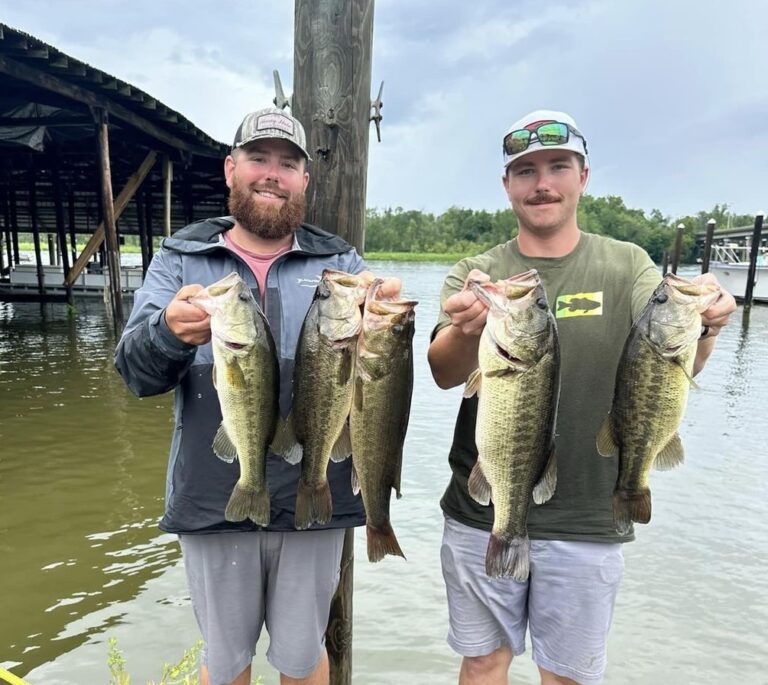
[{"x1": 179, "y1": 529, "x2": 344, "y2": 685}]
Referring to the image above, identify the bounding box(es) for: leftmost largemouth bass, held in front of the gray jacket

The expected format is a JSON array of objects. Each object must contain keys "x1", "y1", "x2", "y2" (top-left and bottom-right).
[{"x1": 190, "y1": 272, "x2": 279, "y2": 526}]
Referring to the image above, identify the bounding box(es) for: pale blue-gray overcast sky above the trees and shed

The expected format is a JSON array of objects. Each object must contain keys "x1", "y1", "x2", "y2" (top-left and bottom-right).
[{"x1": 0, "y1": 0, "x2": 768, "y2": 220}]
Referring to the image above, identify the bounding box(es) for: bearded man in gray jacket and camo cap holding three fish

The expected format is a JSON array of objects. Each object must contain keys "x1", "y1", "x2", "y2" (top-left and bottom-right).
[{"x1": 115, "y1": 108, "x2": 390, "y2": 685}]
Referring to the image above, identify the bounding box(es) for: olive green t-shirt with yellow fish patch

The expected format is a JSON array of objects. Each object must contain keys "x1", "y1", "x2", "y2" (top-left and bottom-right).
[{"x1": 433, "y1": 233, "x2": 661, "y2": 542}]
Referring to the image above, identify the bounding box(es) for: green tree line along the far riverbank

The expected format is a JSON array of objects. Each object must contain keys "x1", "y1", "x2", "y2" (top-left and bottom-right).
[{"x1": 365, "y1": 195, "x2": 754, "y2": 262}]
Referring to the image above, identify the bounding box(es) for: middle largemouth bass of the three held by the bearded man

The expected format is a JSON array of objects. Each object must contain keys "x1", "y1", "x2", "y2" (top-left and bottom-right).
[{"x1": 284, "y1": 270, "x2": 367, "y2": 530}]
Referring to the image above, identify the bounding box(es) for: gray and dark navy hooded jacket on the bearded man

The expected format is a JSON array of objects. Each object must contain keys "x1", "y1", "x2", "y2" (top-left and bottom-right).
[{"x1": 115, "y1": 217, "x2": 365, "y2": 533}]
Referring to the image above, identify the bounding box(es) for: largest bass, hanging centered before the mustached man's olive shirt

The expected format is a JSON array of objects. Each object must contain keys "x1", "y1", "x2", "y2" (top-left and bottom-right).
[{"x1": 464, "y1": 270, "x2": 560, "y2": 581}]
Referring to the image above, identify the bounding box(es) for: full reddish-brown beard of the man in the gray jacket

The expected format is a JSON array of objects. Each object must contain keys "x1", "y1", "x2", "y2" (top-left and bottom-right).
[{"x1": 229, "y1": 178, "x2": 307, "y2": 240}]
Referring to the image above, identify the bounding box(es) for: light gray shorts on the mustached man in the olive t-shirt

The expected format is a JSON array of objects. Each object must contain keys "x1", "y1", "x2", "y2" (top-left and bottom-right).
[{"x1": 440, "y1": 517, "x2": 624, "y2": 685}]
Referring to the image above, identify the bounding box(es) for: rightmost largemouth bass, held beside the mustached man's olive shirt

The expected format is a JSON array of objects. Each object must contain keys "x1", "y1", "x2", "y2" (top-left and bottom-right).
[{"x1": 597, "y1": 274, "x2": 720, "y2": 535}]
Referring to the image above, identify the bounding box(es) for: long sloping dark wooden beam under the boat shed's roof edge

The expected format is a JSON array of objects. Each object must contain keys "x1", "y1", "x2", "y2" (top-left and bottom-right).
[{"x1": 0, "y1": 54, "x2": 221, "y2": 158}]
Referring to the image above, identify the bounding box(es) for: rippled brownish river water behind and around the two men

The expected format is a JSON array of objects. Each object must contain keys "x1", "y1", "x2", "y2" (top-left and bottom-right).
[{"x1": 0, "y1": 262, "x2": 768, "y2": 685}]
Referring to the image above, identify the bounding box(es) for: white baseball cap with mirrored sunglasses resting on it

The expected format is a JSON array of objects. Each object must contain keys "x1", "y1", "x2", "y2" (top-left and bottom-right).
[{"x1": 502, "y1": 109, "x2": 589, "y2": 172}]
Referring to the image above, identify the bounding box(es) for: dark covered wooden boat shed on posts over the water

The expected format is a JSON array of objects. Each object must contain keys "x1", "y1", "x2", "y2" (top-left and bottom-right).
[{"x1": 0, "y1": 24, "x2": 228, "y2": 321}]
